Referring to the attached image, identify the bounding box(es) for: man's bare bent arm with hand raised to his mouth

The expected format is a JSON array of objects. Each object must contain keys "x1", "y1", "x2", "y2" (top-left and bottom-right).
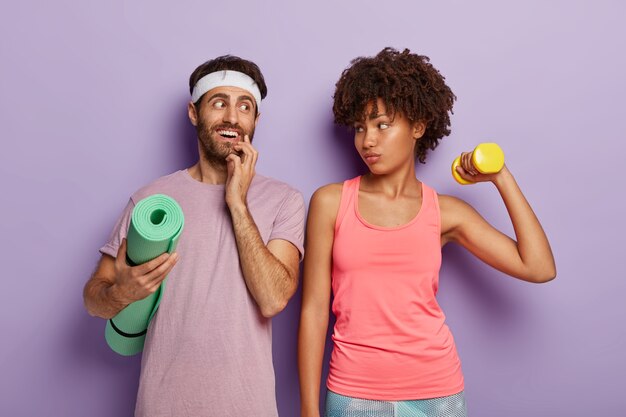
[{"x1": 225, "y1": 135, "x2": 300, "y2": 317}]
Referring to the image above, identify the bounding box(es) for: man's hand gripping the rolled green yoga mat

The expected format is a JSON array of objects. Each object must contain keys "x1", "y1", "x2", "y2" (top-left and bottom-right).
[{"x1": 111, "y1": 239, "x2": 178, "y2": 304}]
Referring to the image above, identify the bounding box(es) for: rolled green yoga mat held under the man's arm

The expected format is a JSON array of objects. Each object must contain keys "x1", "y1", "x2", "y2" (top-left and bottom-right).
[{"x1": 104, "y1": 194, "x2": 185, "y2": 356}]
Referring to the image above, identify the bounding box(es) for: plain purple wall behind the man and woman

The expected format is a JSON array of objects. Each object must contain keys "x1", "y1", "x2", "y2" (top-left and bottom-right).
[{"x1": 0, "y1": 0, "x2": 626, "y2": 417}]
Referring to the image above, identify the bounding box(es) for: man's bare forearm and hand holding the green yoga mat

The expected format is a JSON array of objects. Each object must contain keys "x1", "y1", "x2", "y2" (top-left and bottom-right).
[{"x1": 83, "y1": 239, "x2": 178, "y2": 319}]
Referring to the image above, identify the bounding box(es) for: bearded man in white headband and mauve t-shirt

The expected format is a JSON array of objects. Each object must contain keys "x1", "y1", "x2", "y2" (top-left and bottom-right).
[{"x1": 84, "y1": 55, "x2": 305, "y2": 417}]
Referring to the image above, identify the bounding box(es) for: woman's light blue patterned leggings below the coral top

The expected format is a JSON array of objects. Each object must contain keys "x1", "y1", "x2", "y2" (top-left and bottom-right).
[{"x1": 324, "y1": 390, "x2": 467, "y2": 417}]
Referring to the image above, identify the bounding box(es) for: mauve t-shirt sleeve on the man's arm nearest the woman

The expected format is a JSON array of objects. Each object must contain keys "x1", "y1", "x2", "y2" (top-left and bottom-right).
[{"x1": 269, "y1": 191, "x2": 306, "y2": 260}]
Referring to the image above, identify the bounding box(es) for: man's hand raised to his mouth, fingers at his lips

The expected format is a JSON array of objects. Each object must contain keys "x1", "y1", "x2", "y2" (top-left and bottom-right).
[{"x1": 225, "y1": 135, "x2": 259, "y2": 209}]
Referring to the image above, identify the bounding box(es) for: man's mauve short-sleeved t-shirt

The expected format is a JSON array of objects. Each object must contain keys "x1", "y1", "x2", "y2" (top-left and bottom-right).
[{"x1": 100, "y1": 170, "x2": 305, "y2": 417}]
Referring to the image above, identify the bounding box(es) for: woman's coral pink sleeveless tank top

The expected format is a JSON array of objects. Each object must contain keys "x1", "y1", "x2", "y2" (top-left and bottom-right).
[{"x1": 327, "y1": 177, "x2": 463, "y2": 401}]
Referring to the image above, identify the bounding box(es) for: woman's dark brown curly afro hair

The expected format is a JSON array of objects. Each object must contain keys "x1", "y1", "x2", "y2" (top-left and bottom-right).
[{"x1": 333, "y1": 48, "x2": 456, "y2": 163}]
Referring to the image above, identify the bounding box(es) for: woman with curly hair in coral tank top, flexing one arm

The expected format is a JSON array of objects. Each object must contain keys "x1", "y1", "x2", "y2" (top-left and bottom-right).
[{"x1": 298, "y1": 48, "x2": 556, "y2": 417}]
